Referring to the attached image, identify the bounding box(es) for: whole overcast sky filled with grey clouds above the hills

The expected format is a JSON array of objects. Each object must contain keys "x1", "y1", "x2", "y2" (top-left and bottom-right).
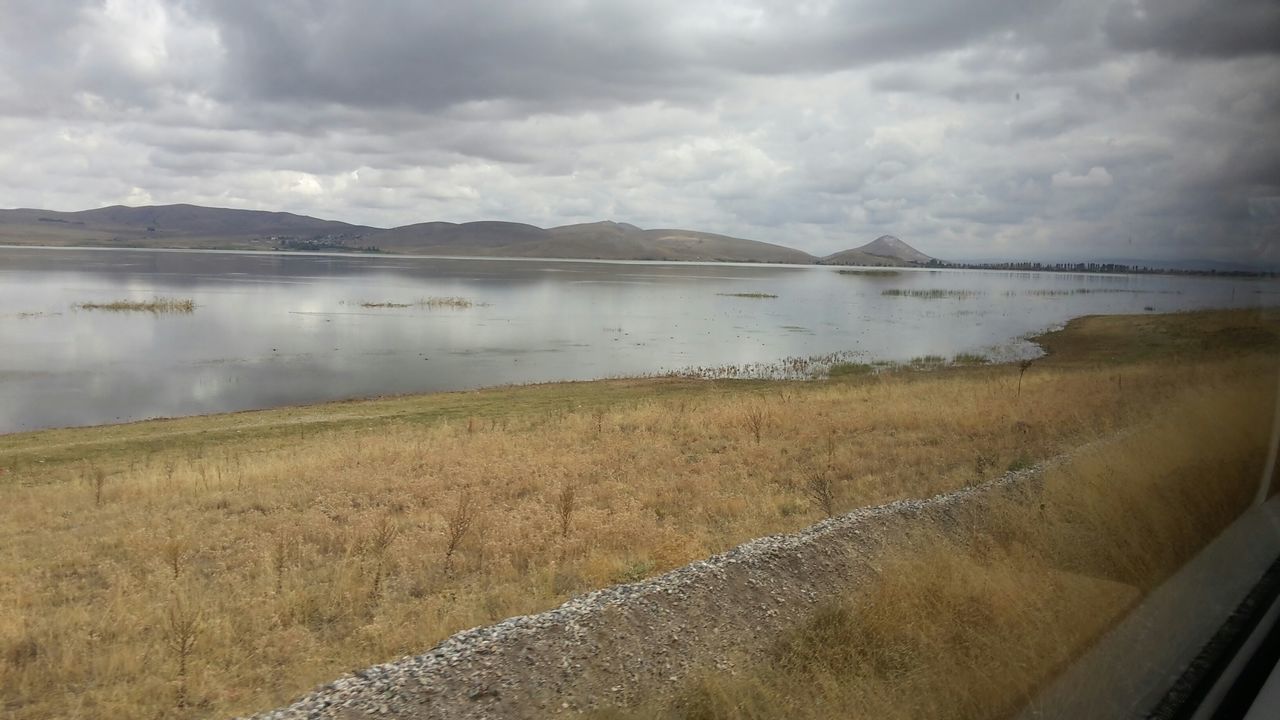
[{"x1": 0, "y1": 0, "x2": 1280, "y2": 264}]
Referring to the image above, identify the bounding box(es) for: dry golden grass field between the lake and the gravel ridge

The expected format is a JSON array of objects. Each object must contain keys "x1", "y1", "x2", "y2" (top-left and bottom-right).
[{"x1": 0, "y1": 304, "x2": 1277, "y2": 719}]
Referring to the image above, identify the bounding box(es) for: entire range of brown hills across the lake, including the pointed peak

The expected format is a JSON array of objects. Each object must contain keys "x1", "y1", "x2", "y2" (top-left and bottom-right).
[{"x1": 0, "y1": 205, "x2": 932, "y2": 266}]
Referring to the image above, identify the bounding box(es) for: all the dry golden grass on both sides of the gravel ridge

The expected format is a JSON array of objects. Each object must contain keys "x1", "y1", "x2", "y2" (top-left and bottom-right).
[{"x1": 0, "y1": 313, "x2": 1280, "y2": 719}]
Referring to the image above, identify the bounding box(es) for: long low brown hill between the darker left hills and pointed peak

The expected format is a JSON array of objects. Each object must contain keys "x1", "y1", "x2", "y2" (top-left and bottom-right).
[{"x1": 366, "y1": 220, "x2": 815, "y2": 264}]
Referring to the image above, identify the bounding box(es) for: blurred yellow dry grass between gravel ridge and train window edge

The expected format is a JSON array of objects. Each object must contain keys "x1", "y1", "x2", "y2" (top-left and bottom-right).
[{"x1": 623, "y1": 364, "x2": 1275, "y2": 720}]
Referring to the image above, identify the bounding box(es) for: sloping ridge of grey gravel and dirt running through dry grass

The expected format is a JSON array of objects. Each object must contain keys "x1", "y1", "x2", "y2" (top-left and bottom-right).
[{"x1": 244, "y1": 461, "x2": 1041, "y2": 720}]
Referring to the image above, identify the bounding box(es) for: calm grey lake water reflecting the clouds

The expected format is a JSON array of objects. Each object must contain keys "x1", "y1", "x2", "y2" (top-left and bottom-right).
[{"x1": 0, "y1": 247, "x2": 1275, "y2": 433}]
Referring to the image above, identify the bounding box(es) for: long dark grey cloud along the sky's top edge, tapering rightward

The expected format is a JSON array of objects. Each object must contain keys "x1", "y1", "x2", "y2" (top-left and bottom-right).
[{"x1": 192, "y1": 0, "x2": 1060, "y2": 110}]
